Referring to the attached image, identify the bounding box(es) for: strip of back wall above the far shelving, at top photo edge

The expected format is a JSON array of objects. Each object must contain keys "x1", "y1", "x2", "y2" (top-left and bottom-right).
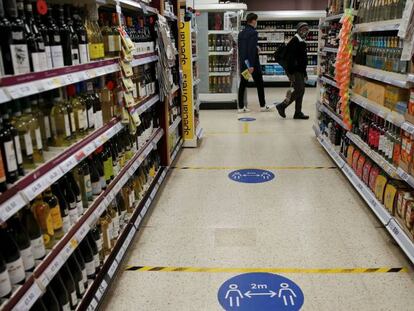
[{"x1": 245, "y1": 0, "x2": 328, "y2": 11}]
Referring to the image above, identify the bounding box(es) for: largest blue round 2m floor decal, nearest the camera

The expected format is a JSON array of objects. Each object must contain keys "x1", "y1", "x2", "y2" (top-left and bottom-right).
[{"x1": 218, "y1": 273, "x2": 304, "y2": 311}]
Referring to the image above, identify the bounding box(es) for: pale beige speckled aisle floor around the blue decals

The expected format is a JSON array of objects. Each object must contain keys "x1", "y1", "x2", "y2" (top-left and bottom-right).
[{"x1": 103, "y1": 89, "x2": 414, "y2": 311}]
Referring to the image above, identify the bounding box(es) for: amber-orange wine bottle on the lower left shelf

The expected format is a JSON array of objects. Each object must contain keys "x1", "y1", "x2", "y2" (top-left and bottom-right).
[{"x1": 32, "y1": 194, "x2": 55, "y2": 248}]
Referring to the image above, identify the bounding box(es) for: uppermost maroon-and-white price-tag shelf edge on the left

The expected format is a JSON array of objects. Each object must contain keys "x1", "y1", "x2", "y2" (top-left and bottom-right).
[{"x1": 0, "y1": 53, "x2": 158, "y2": 103}]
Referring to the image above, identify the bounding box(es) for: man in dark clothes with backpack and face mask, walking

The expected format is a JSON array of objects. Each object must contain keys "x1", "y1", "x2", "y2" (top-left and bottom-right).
[{"x1": 276, "y1": 23, "x2": 309, "y2": 120}]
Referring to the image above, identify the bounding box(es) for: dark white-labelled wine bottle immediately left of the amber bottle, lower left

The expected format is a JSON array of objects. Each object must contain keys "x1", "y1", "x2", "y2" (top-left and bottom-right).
[{"x1": 22, "y1": 205, "x2": 46, "y2": 260}]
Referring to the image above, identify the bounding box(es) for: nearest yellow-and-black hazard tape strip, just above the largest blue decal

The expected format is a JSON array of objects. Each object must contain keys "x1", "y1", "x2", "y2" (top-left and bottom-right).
[{"x1": 126, "y1": 266, "x2": 408, "y2": 274}]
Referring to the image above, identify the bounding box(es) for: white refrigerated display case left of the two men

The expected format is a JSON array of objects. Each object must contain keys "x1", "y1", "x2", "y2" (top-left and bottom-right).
[{"x1": 195, "y1": 3, "x2": 247, "y2": 108}]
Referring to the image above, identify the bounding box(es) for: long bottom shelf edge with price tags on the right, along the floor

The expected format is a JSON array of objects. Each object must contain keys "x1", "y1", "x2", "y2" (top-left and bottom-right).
[{"x1": 314, "y1": 126, "x2": 414, "y2": 262}]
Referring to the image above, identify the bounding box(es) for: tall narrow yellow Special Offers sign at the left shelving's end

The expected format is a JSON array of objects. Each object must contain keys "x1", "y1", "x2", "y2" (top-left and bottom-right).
[{"x1": 180, "y1": 14, "x2": 195, "y2": 140}]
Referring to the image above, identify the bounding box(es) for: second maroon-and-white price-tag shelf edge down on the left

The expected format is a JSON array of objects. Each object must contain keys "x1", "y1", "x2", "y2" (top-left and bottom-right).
[{"x1": 0, "y1": 119, "x2": 123, "y2": 223}]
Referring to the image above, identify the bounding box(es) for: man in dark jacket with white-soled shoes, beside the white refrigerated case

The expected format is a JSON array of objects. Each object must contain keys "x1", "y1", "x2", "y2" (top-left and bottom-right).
[{"x1": 238, "y1": 13, "x2": 271, "y2": 113}]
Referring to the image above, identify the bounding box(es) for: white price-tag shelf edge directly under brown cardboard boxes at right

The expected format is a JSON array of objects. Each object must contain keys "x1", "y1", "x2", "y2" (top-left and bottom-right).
[{"x1": 350, "y1": 92, "x2": 404, "y2": 127}]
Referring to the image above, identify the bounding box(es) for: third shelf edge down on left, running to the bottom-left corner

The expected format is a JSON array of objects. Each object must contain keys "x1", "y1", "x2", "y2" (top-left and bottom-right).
[{"x1": 0, "y1": 129, "x2": 164, "y2": 310}]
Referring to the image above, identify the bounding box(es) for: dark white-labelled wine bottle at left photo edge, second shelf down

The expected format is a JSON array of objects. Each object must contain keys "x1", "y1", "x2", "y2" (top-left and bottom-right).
[{"x1": 0, "y1": 111, "x2": 19, "y2": 185}]
